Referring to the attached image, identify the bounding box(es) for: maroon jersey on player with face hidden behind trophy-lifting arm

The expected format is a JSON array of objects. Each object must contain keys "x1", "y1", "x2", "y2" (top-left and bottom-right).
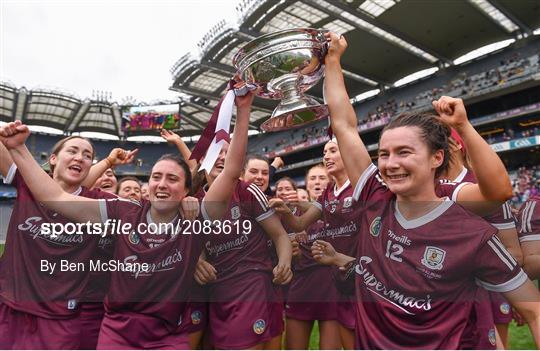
[{"x1": 201, "y1": 180, "x2": 274, "y2": 283}]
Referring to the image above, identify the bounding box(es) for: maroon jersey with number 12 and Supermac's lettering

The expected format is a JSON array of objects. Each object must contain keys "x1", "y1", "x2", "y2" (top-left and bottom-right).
[{"x1": 348, "y1": 165, "x2": 527, "y2": 349}]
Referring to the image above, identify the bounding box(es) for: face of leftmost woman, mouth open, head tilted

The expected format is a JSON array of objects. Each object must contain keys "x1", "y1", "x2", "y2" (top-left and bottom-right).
[{"x1": 49, "y1": 138, "x2": 93, "y2": 185}]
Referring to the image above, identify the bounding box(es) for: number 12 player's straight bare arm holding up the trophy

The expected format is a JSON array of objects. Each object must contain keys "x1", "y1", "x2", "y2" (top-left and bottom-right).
[{"x1": 324, "y1": 33, "x2": 371, "y2": 189}]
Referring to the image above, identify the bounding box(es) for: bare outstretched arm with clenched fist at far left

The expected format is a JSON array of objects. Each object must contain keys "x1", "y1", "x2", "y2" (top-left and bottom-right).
[{"x1": 0, "y1": 121, "x2": 101, "y2": 222}]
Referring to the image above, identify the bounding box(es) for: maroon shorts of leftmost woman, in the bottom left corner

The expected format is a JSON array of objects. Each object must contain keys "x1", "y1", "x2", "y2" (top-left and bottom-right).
[{"x1": 0, "y1": 303, "x2": 81, "y2": 350}]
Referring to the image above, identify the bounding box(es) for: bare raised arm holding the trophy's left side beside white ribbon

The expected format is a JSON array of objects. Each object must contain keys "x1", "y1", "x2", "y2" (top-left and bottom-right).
[{"x1": 203, "y1": 84, "x2": 255, "y2": 219}]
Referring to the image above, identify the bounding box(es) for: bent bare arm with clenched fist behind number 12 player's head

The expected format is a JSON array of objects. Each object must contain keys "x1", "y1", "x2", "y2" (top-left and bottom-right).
[{"x1": 433, "y1": 96, "x2": 512, "y2": 215}]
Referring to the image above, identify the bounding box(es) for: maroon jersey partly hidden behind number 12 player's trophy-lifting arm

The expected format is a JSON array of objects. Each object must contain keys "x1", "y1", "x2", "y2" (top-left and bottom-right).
[{"x1": 315, "y1": 180, "x2": 361, "y2": 256}]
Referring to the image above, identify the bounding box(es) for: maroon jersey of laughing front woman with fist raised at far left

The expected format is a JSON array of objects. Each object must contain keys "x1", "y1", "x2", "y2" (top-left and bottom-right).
[{"x1": 100, "y1": 198, "x2": 202, "y2": 333}]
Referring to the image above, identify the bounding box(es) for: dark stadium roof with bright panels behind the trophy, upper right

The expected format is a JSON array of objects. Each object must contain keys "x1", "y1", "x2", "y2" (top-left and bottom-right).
[{"x1": 171, "y1": 0, "x2": 540, "y2": 130}]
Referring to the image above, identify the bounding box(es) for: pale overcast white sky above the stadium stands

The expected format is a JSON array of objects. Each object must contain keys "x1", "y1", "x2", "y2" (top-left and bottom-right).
[{"x1": 0, "y1": 0, "x2": 237, "y2": 102}]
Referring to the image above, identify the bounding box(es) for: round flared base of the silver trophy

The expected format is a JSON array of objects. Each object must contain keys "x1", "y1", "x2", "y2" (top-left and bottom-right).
[{"x1": 261, "y1": 104, "x2": 330, "y2": 132}]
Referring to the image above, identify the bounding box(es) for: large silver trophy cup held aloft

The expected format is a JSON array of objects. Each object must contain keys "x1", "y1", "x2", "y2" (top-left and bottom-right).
[{"x1": 233, "y1": 28, "x2": 329, "y2": 131}]
